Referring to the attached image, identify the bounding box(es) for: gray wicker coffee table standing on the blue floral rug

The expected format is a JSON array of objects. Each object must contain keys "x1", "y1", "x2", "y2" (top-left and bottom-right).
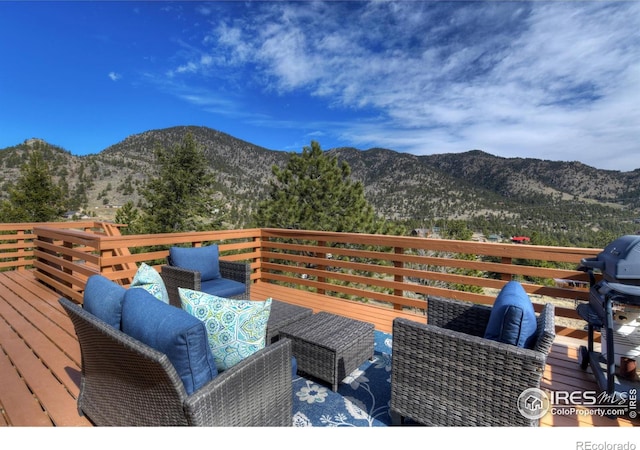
[{"x1": 280, "y1": 312, "x2": 374, "y2": 391}]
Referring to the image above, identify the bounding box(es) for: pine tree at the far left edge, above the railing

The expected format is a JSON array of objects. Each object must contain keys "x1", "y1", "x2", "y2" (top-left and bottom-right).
[{"x1": 0, "y1": 150, "x2": 65, "y2": 223}]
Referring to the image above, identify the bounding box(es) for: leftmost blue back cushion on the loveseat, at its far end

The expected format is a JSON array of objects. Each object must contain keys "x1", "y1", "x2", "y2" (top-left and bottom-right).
[{"x1": 82, "y1": 275, "x2": 127, "y2": 330}]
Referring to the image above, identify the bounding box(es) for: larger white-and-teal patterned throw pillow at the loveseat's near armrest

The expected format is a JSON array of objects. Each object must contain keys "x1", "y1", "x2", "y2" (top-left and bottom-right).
[{"x1": 178, "y1": 288, "x2": 271, "y2": 372}]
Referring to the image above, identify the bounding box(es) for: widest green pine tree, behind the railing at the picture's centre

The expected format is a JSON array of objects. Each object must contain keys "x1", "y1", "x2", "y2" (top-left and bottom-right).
[{"x1": 254, "y1": 141, "x2": 392, "y2": 233}]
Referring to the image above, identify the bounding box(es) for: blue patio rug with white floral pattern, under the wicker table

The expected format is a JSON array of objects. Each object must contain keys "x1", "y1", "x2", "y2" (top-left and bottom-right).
[{"x1": 293, "y1": 331, "x2": 392, "y2": 427}]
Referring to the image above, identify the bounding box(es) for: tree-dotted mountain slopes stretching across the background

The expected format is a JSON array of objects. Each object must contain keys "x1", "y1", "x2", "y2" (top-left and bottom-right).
[{"x1": 0, "y1": 126, "x2": 640, "y2": 241}]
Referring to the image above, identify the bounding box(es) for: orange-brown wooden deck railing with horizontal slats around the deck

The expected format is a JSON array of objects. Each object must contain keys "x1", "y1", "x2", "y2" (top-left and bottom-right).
[{"x1": 0, "y1": 222, "x2": 601, "y2": 338}]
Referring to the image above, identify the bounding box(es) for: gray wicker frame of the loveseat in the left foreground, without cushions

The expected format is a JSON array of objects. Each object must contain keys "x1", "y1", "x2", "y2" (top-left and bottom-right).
[{"x1": 60, "y1": 298, "x2": 293, "y2": 426}]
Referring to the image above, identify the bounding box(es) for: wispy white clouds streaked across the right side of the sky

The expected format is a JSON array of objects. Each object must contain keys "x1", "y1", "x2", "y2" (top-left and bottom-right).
[{"x1": 166, "y1": 1, "x2": 640, "y2": 170}]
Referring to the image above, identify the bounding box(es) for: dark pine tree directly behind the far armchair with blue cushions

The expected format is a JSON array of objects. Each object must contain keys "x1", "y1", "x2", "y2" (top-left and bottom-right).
[{"x1": 141, "y1": 133, "x2": 223, "y2": 233}]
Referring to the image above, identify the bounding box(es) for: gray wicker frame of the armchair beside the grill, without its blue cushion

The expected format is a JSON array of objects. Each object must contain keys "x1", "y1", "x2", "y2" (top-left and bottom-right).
[{"x1": 390, "y1": 297, "x2": 555, "y2": 426}]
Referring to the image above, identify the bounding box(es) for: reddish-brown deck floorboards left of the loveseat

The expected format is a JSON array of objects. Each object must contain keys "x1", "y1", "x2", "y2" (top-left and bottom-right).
[{"x1": 0, "y1": 271, "x2": 90, "y2": 426}]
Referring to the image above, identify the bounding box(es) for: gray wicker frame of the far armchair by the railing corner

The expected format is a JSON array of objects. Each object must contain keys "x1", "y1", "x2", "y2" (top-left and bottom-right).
[{"x1": 160, "y1": 259, "x2": 251, "y2": 308}]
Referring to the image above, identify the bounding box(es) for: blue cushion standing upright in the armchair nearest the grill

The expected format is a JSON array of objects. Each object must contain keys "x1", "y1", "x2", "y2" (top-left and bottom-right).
[{"x1": 484, "y1": 281, "x2": 538, "y2": 348}]
